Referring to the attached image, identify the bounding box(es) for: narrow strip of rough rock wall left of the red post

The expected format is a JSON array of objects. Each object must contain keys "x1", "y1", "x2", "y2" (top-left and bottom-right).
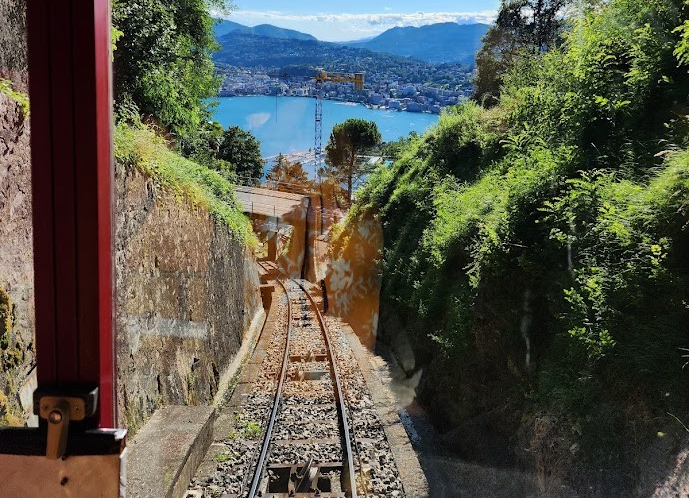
[{"x1": 0, "y1": 88, "x2": 36, "y2": 425}]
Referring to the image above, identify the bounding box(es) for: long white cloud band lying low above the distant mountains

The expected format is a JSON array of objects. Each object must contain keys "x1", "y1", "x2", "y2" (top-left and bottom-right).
[{"x1": 215, "y1": 8, "x2": 497, "y2": 41}]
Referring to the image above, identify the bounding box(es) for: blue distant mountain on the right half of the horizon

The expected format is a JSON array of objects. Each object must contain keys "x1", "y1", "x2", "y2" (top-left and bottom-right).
[{"x1": 347, "y1": 22, "x2": 490, "y2": 65}]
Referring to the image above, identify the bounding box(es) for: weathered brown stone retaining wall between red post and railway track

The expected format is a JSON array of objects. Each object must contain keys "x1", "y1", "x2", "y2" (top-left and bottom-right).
[{"x1": 115, "y1": 165, "x2": 261, "y2": 432}]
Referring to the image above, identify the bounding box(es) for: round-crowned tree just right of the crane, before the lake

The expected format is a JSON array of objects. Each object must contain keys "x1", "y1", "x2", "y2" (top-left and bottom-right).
[{"x1": 325, "y1": 118, "x2": 381, "y2": 201}]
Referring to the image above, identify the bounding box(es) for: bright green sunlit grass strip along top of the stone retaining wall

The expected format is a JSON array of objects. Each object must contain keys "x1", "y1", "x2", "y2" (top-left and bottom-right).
[{"x1": 115, "y1": 123, "x2": 255, "y2": 244}]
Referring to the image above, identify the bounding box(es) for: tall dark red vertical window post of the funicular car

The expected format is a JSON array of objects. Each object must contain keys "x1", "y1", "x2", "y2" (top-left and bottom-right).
[{"x1": 27, "y1": 0, "x2": 116, "y2": 427}]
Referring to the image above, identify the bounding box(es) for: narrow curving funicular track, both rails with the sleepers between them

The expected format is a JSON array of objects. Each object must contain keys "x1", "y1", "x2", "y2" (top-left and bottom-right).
[{"x1": 253, "y1": 262, "x2": 362, "y2": 498}]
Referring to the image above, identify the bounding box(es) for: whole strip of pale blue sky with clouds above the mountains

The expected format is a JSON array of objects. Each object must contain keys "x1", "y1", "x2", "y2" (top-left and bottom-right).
[{"x1": 216, "y1": 0, "x2": 500, "y2": 41}]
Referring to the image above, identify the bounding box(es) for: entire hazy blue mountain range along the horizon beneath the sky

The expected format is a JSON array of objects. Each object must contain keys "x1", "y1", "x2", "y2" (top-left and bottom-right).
[{"x1": 214, "y1": 20, "x2": 489, "y2": 66}]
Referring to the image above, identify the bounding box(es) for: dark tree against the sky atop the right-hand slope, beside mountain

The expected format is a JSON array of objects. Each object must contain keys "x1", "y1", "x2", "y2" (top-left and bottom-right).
[{"x1": 473, "y1": 0, "x2": 574, "y2": 106}]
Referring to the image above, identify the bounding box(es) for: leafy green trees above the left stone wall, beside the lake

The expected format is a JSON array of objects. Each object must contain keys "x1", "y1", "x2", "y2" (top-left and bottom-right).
[{"x1": 112, "y1": 0, "x2": 263, "y2": 179}]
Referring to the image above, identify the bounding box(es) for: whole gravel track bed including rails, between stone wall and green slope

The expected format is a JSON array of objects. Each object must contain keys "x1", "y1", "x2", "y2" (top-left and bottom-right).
[{"x1": 186, "y1": 263, "x2": 416, "y2": 498}]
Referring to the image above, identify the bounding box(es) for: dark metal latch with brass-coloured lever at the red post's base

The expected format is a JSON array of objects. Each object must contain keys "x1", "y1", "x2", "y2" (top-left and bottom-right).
[{"x1": 34, "y1": 387, "x2": 98, "y2": 460}]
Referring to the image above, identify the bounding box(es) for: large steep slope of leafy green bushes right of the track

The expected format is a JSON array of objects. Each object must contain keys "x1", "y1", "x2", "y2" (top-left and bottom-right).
[{"x1": 349, "y1": 0, "x2": 689, "y2": 486}]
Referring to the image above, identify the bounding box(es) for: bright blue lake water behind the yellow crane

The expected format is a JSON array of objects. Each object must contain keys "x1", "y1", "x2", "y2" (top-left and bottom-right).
[{"x1": 213, "y1": 97, "x2": 438, "y2": 172}]
